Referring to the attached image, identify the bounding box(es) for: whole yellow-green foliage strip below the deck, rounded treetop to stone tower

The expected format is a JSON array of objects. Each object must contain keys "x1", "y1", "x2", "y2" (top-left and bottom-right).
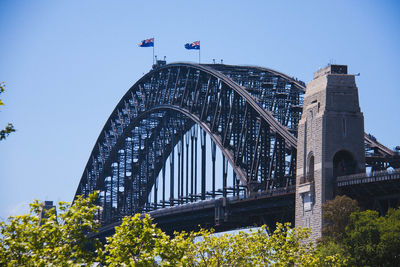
[{"x1": 105, "y1": 218, "x2": 343, "y2": 266}]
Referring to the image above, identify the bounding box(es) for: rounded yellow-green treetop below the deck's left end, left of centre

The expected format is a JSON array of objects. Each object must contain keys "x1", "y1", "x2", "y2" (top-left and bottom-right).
[{"x1": 104, "y1": 214, "x2": 193, "y2": 266}]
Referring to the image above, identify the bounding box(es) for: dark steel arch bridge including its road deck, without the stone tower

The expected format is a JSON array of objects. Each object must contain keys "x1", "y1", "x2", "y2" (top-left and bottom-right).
[{"x1": 76, "y1": 61, "x2": 400, "y2": 238}]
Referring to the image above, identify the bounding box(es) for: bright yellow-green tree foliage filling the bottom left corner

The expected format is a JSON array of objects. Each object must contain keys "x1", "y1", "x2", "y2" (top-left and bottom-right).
[{"x1": 0, "y1": 194, "x2": 100, "y2": 266}]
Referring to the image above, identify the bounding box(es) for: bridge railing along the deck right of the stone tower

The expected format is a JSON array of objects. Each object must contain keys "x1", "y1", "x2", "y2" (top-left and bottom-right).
[{"x1": 336, "y1": 169, "x2": 400, "y2": 187}]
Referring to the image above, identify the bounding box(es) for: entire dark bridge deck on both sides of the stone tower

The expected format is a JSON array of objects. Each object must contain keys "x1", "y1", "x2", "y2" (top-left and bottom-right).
[{"x1": 96, "y1": 169, "x2": 400, "y2": 237}]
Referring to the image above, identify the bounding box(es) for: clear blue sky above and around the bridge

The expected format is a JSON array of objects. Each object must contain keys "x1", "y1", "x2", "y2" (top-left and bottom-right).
[{"x1": 0, "y1": 0, "x2": 400, "y2": 220}]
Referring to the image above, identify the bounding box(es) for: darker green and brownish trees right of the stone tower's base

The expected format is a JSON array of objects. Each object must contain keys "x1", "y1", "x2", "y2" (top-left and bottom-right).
[{"x1": 317, "y1": 197, "x2": 400, "y2": 266}]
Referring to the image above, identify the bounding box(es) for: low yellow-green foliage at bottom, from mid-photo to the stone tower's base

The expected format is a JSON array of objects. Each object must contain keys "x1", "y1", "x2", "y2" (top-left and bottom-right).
[{"x1": 186, "y1": 223, "x2": 343, "y2": 266}]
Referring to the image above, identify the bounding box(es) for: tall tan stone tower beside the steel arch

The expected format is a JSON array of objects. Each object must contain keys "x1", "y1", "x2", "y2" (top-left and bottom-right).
[{"x1": 295, "y1": 65, "x2": 365, "y2": 240}]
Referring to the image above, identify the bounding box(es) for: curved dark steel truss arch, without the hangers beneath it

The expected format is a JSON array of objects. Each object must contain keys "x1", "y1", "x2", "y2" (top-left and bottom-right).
[{"x1": 76, "y1": 63, "x2": 304, "y2": 222}]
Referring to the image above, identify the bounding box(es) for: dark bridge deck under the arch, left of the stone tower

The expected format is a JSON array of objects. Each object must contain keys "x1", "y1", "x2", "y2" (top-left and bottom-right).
[{"x1": 96, "y1": 186, "x2": 295, "y2": 237}]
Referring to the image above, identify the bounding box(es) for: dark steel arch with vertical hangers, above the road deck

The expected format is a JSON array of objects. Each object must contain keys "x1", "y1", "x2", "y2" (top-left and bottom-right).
[{"x1": 75, "y1": 63, "x2": 392, "y2": 233}]
